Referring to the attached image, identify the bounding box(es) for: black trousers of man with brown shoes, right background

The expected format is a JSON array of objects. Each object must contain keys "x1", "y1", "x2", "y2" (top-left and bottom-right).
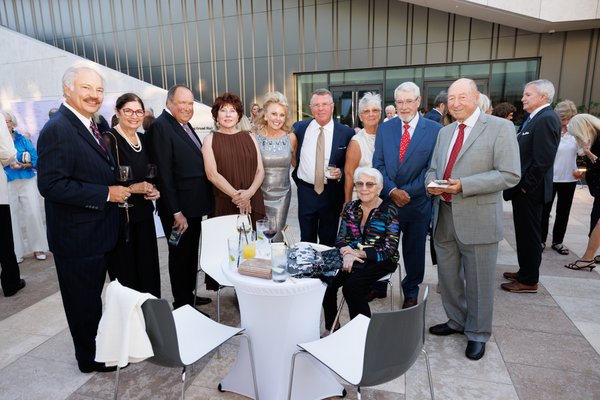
[{"x1": 512, "y1": 190, "x2": 544, "y2": 285}]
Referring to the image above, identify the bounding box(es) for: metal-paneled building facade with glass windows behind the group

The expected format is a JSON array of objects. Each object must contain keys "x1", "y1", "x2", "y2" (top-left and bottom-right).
[{"x1": 0, "y1": 0, "x2": 600, "y2": 125}]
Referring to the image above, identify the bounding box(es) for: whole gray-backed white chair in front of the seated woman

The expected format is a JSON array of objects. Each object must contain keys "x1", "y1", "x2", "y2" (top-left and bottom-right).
[{"x1": 288, "y1": 287, "x2": 434, "y2": 400}]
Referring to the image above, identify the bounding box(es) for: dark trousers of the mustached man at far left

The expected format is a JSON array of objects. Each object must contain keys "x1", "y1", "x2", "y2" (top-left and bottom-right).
[{"x1": 54, "y1": 254, "x2": 108, "y2": 368}]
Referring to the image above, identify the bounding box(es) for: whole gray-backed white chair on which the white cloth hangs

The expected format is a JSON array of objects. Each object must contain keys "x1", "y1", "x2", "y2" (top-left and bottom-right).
[{"x1": 114, "y1": 299, "x2": 258, "y2": 400}]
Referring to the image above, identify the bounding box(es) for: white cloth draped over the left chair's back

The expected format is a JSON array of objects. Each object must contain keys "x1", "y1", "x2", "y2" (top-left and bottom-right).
[{"x1": 96, "y1": 280, "x2": 156, "y2": 367}]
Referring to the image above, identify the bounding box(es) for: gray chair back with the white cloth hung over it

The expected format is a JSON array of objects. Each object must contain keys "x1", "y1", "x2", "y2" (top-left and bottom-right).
[{"x1": 142, "y1": 299, "x2": 185, "y2": 368}]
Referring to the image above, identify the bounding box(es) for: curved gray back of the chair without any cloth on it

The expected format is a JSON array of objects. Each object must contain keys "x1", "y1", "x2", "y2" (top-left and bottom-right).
[{"x1": 359, "y1": 287, "x2": 429, "y2": 386}]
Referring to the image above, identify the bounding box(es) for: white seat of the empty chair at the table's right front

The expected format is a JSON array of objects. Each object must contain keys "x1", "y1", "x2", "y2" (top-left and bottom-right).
[{"x1": 298, "y1": 314, "x2": 370, "y2": 385}]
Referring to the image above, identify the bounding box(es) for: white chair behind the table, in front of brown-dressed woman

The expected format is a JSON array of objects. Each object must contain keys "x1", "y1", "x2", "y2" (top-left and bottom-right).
[{"x1": 196, "y1": 214, "x2": 238, "y2": 322}]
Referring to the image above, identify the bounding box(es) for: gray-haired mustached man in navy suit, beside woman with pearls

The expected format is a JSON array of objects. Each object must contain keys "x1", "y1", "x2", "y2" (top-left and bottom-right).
[{"x1": 38, "y1": 66, "x2": 130, "y2": 372}]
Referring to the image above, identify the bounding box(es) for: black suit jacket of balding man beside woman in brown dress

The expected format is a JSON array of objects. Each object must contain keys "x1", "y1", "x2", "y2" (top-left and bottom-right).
[{"x1": 146, "y1": 110, "x2": 214, "y2": 218}]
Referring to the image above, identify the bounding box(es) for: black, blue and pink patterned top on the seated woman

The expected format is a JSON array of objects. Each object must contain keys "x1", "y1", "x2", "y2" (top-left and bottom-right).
[{"x1": 335, "y1": 200, "x2": 400, "y2": 266}]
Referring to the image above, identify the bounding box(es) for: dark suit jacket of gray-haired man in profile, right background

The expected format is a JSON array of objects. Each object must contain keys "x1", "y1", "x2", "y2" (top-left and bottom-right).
[{"x1": 504, "y1": 105, "x2": 561, "y2": 203}]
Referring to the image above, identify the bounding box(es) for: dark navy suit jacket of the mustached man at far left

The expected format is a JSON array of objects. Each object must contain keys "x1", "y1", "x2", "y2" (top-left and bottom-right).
[{"x1": 37, "y1": 105, "x2": 119, "y2": 257}]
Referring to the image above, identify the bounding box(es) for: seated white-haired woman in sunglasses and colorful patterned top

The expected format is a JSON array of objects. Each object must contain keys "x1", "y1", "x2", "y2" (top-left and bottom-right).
[{"x1": 322, "y1": 167, "x2": 399, "y2": 336}]
